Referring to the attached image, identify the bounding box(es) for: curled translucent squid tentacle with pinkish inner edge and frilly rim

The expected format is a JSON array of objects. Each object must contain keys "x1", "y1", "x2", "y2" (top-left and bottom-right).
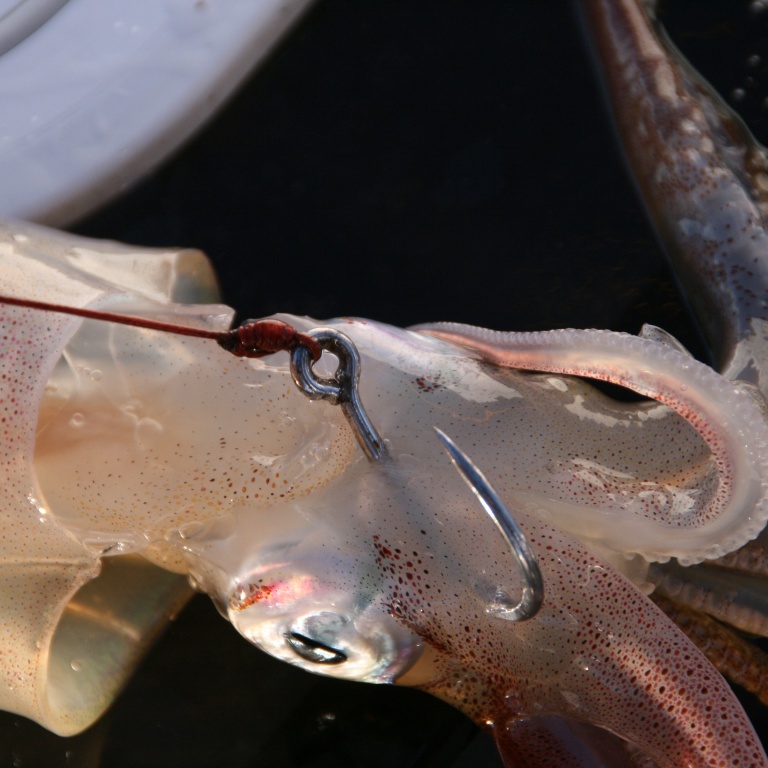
[{"x1": 413, "y1": 323, "x2": 768, "y2": 565}]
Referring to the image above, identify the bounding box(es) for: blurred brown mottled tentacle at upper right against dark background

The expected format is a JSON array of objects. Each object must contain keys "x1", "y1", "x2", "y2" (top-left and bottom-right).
[{"x1": 581, "y1": 0, "x2": 768, "y2": 384}]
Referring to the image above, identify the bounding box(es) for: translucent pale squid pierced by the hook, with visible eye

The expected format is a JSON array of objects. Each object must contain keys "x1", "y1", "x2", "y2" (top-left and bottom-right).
[{"x1": 0, "y1": 219, "x2": 768, "y2": 766}]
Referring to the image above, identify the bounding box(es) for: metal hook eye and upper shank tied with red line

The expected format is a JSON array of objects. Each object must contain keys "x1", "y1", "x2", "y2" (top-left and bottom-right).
[{"x1": 291, "y1": 328, "x2": 389, "y2": 461}]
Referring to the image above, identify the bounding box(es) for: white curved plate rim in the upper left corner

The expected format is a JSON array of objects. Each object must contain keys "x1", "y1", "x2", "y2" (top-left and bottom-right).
[{"x1": 0, "y1": 0, "x2": 312, "y2": 226}]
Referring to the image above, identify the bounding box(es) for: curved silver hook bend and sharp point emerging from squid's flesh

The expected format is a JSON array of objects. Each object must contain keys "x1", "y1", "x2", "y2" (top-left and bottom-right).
[{"x1": 433, "y1": 427, "x2": 544, "y2": 621}]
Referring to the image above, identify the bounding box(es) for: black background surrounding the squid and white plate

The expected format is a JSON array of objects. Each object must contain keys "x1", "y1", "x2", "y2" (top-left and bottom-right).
[{"x1": 0, "y1": 0, "x2": 768, "y2": 768}]
